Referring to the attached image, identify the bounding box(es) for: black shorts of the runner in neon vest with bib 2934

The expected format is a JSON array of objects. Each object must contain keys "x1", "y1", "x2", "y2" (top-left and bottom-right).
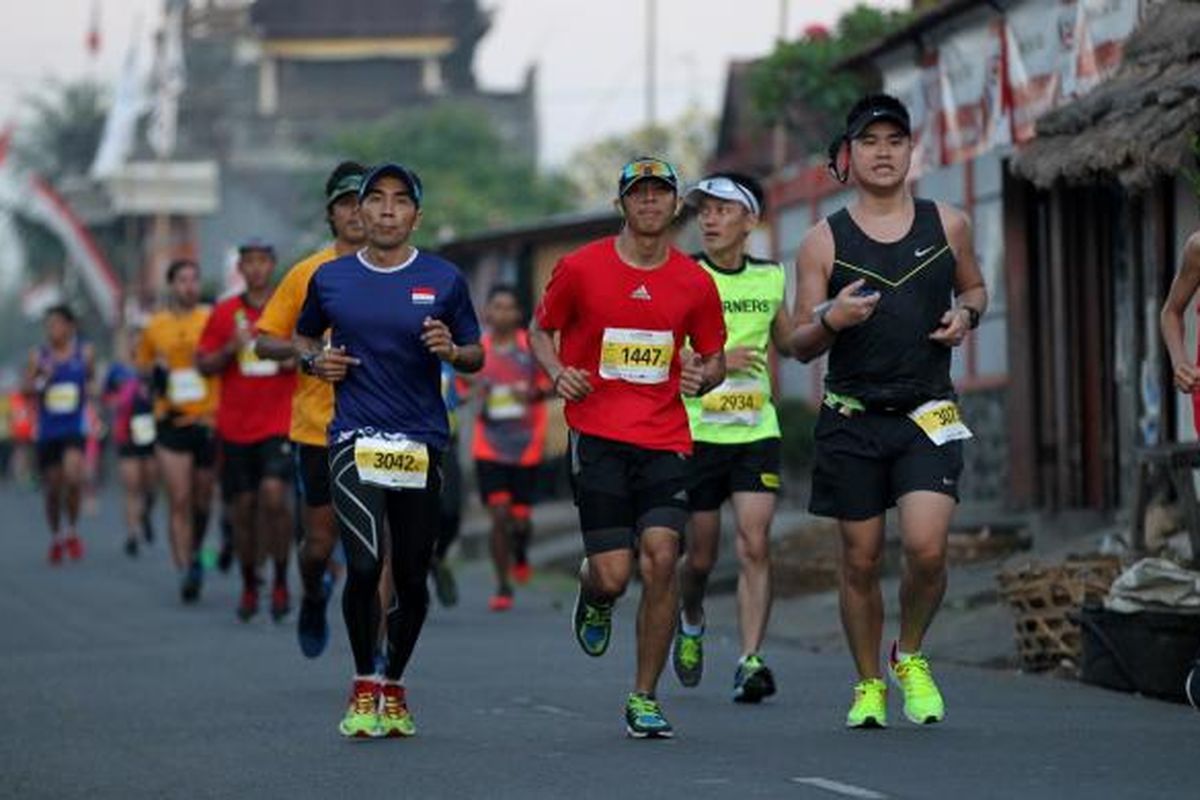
[{"x1": 688, "y1": 437, "x2": 780, "y2": 511}]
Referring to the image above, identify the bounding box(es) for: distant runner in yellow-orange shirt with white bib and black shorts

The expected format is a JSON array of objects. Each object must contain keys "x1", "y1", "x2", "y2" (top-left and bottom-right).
[{"x1": 136, "y1": 260, "x2": 217, "y2": 603}]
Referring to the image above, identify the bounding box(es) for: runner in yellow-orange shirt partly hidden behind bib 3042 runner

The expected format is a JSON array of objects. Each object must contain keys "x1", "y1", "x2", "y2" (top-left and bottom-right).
[{"x1": 258, "y1": 162, "x2": 366, "y2": 658}]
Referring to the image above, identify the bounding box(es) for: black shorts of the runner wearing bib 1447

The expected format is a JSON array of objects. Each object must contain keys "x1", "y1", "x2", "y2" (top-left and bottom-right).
[{"x1": 569, "y1": 431, "x2": 689, "y2": 555}]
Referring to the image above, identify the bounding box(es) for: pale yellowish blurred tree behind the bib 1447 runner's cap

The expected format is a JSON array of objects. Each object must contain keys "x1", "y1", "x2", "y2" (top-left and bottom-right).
[{"x1": 570, "y1": 107, "x2": 716, "y2": 207}]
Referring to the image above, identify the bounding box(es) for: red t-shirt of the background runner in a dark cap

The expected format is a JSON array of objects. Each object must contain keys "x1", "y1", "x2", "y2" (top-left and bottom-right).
[{"x1": 196, "y1": 295, "x2": 296, "y2": 444}]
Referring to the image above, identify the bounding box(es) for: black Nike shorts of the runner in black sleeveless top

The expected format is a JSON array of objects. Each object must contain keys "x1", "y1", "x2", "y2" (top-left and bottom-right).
[{"x1": 809, "y1": 405, "x2": 962, "y2": 521}]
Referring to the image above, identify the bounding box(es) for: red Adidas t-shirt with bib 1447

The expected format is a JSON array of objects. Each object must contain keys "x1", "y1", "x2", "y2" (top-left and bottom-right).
[{"x1": 536, "y1": 236, "x2": 725, "y2": 453}]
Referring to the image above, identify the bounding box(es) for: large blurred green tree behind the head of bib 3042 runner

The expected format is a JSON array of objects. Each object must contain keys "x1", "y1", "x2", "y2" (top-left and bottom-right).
[{"x1": 332, "y1": 103, "x2": 575, "y2": 243}]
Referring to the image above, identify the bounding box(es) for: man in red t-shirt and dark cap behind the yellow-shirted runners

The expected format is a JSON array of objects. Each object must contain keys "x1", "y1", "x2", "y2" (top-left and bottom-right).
[{"x1": 196, "y1": 240, "x2": 295, "y2": 621}]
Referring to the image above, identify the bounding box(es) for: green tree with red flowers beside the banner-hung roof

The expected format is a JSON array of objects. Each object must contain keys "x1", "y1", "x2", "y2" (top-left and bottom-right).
[{"x1": 750, "y1": 5, "x2": 912, "y2": 150}]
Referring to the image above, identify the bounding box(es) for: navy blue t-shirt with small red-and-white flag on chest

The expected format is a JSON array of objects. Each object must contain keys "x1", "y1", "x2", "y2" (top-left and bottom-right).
[{"x1": 296, "y1": 249, "x2": 480, "y2": 450}]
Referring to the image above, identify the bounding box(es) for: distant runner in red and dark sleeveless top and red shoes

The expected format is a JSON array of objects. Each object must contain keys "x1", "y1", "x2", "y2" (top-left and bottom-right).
[{"x1": 470, "y1": 285, "x2": 552, "y2": 610}]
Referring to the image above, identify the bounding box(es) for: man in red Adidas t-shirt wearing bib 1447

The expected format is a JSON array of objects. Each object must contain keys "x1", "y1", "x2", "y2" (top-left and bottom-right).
[{"x1": 530, "y1": 158, "x2": 725, "y2": 739}]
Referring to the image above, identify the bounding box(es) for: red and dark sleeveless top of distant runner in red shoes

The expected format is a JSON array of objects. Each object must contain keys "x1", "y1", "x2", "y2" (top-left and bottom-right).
[{"x1": 470, "y1": 330, "x2": 550, "y2": 467}]
